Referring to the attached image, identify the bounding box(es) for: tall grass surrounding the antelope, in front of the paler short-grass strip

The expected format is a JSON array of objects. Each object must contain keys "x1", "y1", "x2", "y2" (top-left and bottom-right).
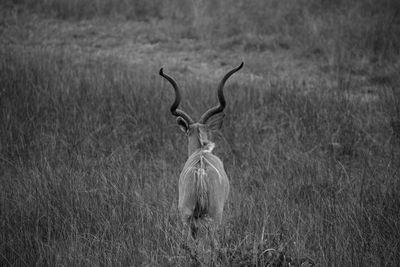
[{"x1": 0, "y1": 44, "x2": 400, "y2": 266}]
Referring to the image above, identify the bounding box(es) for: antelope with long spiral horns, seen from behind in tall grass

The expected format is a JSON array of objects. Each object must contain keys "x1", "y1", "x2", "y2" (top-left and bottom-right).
[{"x1": 159, "y1": 62, "x2": 244, "y2": 239}]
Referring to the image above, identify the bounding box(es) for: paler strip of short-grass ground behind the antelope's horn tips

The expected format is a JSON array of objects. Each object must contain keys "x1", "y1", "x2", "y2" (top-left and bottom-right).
[{"x1": 1, "y1": 11, "x2": 344, "y2": 89}]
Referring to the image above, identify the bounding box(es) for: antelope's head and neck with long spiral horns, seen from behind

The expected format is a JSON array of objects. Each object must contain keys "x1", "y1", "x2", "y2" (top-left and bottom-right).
[{"x1": 160, "y1": 62, "x2": 244, "y2": 156}]
